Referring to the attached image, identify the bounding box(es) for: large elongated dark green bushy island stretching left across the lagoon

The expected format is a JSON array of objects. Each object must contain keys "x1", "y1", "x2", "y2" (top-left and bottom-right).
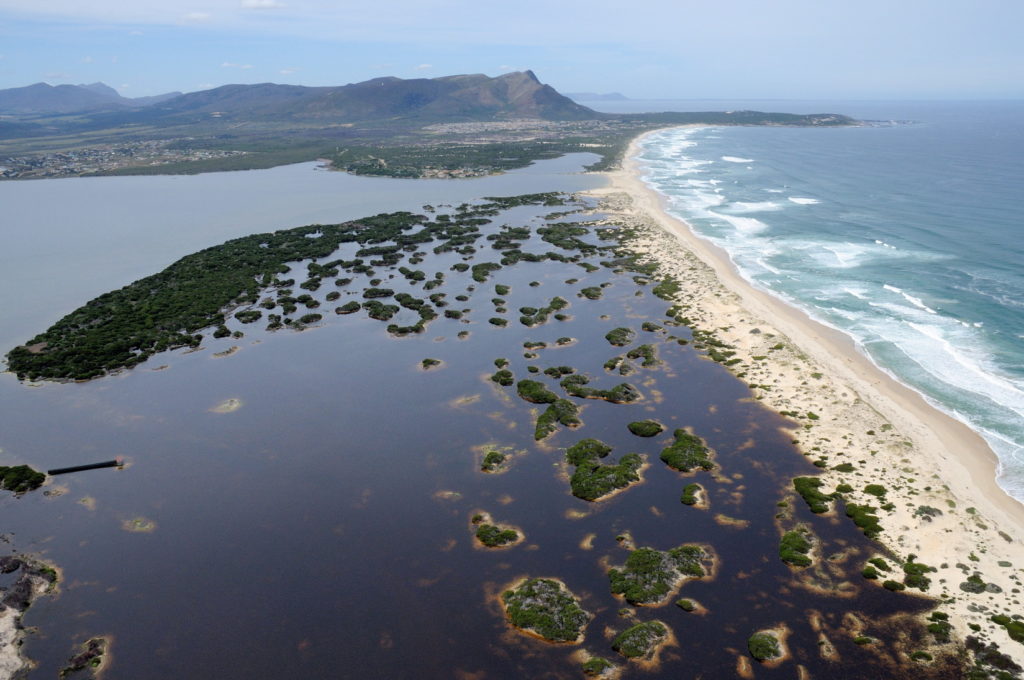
[{"x1": 7, "y1": 194, "x2": 574, "y2": 378}]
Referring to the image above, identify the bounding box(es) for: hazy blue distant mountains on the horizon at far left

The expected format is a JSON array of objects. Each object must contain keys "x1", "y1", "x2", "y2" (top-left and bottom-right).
[{"x1": 0, "y1": 83, "x2": 181, "y2": 116}]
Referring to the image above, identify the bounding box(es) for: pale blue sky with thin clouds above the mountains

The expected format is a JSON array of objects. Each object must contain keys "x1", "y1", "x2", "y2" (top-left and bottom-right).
[{"x1": 0, "y1": 0, "x2": 1024, "y2": 99}]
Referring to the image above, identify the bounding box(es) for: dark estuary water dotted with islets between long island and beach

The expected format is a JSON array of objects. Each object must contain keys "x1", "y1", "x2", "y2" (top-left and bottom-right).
[{"x1": 0, "y1": 157, "x2": 956, "y2": 680}]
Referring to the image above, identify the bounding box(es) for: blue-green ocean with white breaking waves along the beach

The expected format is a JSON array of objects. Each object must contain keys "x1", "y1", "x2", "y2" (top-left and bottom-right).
[{"x1": 598, "y1": 101, "x2": 1024, "y2": 501}]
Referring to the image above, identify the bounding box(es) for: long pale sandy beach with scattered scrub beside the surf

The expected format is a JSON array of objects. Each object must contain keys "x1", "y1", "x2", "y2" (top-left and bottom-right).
[{"x1": 591, "y1": 130, "x2": 1024, "y2": 665}]
